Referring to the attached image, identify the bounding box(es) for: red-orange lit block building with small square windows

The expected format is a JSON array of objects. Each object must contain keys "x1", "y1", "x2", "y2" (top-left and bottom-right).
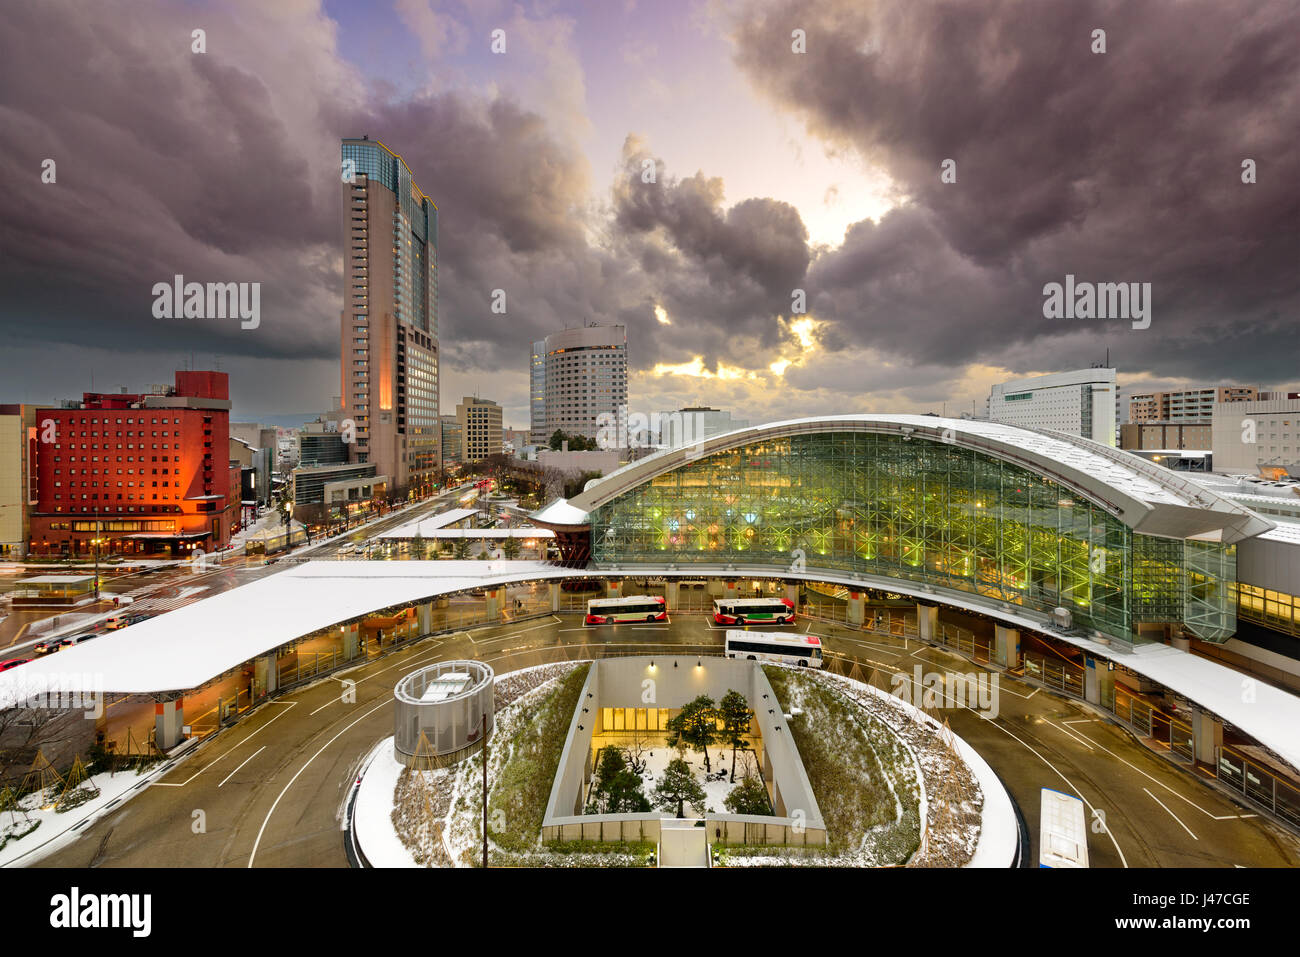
[{"x1": 30, "y1": 372, "x2": 239, "y2": 558}]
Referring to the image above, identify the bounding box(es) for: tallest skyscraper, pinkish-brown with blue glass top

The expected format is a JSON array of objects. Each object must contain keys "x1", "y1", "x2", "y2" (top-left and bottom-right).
[{"x1": 339, "y1": 137, "x2": 442, "y2": 494}]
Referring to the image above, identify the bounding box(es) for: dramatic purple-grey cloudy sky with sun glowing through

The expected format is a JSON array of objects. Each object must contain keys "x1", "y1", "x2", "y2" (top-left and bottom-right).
[{"x1": 0, "y1": 0, "x2": 1300, "y2": 426}]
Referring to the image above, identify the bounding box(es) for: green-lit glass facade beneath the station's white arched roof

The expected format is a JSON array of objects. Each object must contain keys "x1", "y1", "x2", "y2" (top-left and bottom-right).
[{"x1": 590, "y1": 432, "x2": 1236, "y2": 641}]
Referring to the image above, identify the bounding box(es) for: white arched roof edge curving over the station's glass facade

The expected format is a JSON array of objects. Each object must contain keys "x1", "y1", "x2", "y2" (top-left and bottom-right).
[{"x1": 564, "y1": 415, "x2": 1273, "y2": 542}]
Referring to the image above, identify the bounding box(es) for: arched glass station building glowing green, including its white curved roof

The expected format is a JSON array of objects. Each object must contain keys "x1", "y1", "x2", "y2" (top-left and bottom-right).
[{"x1": 534, "y1": 415, "x2": 1273, "y2": 644}]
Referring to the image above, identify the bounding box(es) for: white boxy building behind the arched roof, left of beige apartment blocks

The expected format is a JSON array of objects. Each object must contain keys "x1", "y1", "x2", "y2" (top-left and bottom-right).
[{"x1": 988, "y1": 368, "x2": 1117, "y2": 446}]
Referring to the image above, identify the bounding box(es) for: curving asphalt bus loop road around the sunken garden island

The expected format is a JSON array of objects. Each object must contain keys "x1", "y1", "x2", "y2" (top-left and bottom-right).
[{"x1": 30, "y1": 614, "x2": 1300, "y2": 867}]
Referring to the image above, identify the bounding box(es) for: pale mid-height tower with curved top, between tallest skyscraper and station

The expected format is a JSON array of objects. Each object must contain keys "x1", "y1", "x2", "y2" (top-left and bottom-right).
[{"x1": 533, "y1": 325, "x2": 628, "y2": 441}]
